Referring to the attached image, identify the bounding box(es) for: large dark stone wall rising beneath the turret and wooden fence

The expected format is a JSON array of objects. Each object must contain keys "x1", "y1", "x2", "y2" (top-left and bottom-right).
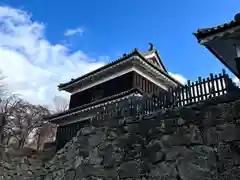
[{"x1": 2, "y1": 93, "x2": 240, "y2": 180}]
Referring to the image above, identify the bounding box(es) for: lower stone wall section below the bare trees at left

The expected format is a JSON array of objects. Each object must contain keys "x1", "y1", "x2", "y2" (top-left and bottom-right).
[{"x1": 0, "y1": 147, "x2": 54, "y2": 180}]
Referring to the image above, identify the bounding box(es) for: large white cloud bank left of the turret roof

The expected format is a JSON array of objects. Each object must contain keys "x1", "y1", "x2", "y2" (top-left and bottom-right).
[{"x1": 0, "y1": 6, "x2": 104, "y2": 107}]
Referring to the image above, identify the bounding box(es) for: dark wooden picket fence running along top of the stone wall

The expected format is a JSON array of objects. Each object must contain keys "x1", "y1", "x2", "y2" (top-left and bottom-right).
[{"x1": 91, "y1": 70, "x2": 239, "y2": 120}]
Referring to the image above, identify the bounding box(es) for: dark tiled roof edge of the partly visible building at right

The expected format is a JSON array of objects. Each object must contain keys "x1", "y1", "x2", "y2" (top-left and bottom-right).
[{"x1": 193, "y1": 20, "x2": 240, "y2": 40}]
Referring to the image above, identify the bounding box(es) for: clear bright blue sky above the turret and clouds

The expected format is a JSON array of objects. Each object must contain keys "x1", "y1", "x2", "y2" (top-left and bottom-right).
[{"x1": 0, "y1": 0, "x2": 240, "y2": 105}]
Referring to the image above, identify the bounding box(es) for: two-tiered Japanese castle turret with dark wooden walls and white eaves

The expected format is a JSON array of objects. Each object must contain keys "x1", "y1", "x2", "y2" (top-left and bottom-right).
[{"x1": 48, "y1": 44, "x2": 182, "y2": 149}]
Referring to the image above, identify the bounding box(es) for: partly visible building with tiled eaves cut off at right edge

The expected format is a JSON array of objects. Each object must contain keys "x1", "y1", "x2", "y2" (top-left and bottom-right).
[{"x1": 194, "y1": 13, "x2": 240, "y2": 78}]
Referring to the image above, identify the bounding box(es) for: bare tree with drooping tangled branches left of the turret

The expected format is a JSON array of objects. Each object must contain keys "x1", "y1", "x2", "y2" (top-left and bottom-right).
[{"x1": 4, "y1": 99, "x2": 50, "y2": 148}]
